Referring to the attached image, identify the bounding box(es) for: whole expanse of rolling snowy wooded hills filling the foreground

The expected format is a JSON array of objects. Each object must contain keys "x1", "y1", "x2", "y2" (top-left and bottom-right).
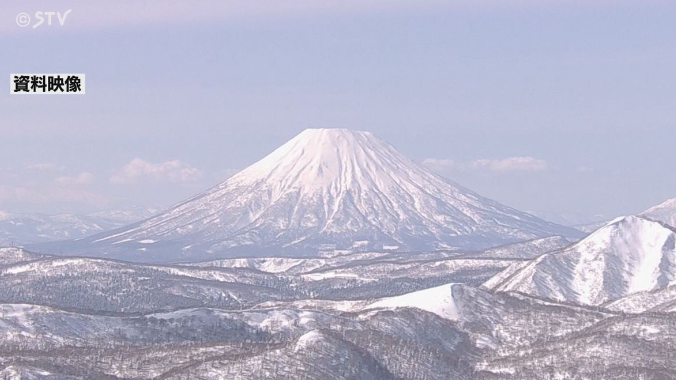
[{"x1": 0, "y1": 245, "x2": 676, "y2": 380}]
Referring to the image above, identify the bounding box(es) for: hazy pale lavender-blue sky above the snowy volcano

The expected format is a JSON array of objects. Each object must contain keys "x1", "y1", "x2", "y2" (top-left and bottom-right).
[{"x1": 0, "y1": 0, "x2": 676, "y2": 223}]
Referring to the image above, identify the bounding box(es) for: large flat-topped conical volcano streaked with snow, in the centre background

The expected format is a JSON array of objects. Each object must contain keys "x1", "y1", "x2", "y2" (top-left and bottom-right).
[{"x1": 41, "y1": 129, "x2": 577, "y2": 260}]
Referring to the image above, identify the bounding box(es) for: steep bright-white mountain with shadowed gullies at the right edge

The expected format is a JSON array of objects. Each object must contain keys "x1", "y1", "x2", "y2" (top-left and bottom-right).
[{"x1": 485, "y1": 216, "x2": 676, "y2": 305}]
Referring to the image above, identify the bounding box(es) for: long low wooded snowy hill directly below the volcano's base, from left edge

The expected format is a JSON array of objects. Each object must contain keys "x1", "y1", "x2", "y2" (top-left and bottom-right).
[{"x1": 0, "y1": 248, "x2": 510, "y2": 312}]
